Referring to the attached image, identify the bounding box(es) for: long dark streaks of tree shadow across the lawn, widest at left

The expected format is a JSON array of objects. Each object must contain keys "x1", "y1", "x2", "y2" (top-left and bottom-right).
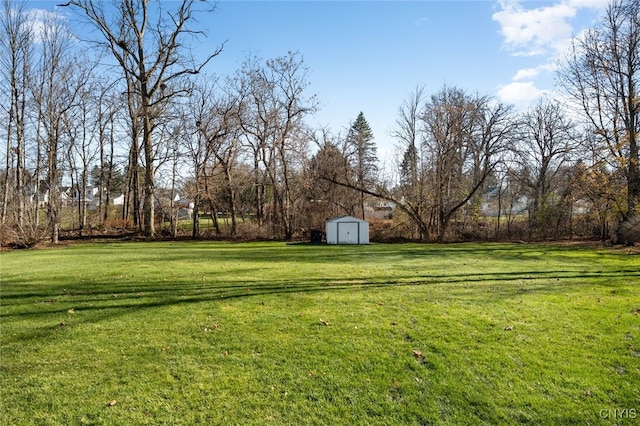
[{"x1": 0, "y1": 270, "x2": 640, "y2": 343}]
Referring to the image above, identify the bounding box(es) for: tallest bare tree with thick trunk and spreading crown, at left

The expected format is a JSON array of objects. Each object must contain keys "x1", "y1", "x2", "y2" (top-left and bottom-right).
[{"x1": 65, "y1": 0, "x2": 222, "y2": 237}]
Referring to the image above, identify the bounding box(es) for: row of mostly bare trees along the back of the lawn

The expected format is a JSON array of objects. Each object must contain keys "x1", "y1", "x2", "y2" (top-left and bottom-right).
[{"x1": 0, "y1": 0, "x2": 640, "y2": 245}]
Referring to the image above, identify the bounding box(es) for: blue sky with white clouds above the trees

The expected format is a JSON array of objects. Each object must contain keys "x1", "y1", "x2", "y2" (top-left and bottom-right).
[{"x1": 29, "y1": 0, "x2": 608, "y2": 161}]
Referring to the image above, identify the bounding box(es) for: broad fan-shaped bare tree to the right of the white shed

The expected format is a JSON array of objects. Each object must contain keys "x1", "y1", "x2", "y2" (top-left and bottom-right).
[{"x1": 424, "y1": 87, "x2": 515, "y2": 241}]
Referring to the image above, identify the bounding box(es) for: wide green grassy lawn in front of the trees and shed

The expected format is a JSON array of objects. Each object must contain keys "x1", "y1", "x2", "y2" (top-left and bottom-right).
[{"x1": 0, "y1": 242, "x2": 640, "y2": 425}]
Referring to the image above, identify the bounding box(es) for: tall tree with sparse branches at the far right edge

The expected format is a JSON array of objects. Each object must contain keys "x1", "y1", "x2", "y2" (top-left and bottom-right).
[{"x1": 559, "y1": 0, "x2": 640, "y2": 241}]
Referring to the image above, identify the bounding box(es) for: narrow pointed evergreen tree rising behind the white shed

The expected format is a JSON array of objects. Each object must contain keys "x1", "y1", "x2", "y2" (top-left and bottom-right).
[{"x1": 347, "y1": 111, "x2": 378, "y2": 219}]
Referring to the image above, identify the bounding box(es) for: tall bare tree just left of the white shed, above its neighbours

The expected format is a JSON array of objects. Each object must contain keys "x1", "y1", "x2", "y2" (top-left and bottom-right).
[{"x1": 235, "y1": 52, "x2": 317, "y2": 239}]
